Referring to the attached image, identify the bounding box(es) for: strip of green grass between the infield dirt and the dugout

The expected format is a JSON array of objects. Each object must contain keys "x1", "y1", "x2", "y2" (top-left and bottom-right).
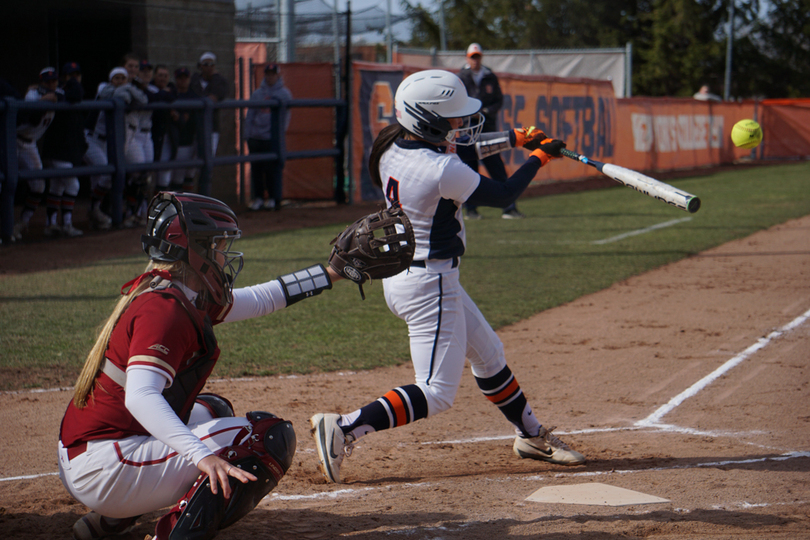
[{"x1": 0, "y1": 163, "x2": 810, "y2": 390}]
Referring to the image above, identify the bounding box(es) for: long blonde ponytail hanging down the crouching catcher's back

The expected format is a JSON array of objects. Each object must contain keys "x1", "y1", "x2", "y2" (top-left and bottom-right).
[{"x1": 73, "y1": 261, "x2": 188, "y2": 409}]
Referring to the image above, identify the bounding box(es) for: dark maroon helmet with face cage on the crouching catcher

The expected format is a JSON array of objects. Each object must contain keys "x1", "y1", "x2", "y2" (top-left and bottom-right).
[{"x1": 141, "y1": 192, "x2": 243, "y2": 306}]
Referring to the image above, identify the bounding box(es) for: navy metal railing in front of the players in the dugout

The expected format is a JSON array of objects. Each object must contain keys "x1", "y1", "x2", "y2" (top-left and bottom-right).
[{"x1": 0, "y1": 98, "x2": 346, "y2": 241}]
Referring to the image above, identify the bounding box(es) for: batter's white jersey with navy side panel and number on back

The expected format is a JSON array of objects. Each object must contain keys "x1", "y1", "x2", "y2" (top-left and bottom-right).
[{"x1": 380, "y1": 139, "x2": 481, "y2": 261}]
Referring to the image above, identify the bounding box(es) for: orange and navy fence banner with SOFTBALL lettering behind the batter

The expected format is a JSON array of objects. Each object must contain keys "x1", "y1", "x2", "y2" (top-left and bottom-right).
[{"x1": 351, "y1": 62, "x2": 810, "y2": 205}]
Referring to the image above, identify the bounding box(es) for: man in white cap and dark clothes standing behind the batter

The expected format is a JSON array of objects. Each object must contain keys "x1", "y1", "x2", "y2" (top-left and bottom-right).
[{"x1": 458, "y1": 43, "x2": 524, "y2": 219}]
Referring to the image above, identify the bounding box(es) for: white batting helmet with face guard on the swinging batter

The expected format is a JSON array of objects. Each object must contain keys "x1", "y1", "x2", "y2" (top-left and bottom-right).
[{"x1": 394, "y1": 69, "x2": 484, "y2": 145}]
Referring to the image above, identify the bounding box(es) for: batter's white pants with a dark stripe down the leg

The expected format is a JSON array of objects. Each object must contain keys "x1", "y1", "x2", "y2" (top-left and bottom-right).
[{"x1": 383, "y1": 260, "x2": 506, "y2": 416}]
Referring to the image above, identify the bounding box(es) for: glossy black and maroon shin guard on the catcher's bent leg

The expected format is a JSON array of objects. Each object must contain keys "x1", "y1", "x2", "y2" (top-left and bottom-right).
[{"x1": 155, "y1": 411, "x2": 296, "y2": 540}]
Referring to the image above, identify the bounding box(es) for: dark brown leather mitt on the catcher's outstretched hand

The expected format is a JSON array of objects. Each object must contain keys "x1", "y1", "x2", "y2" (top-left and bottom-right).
[{"x1": 329, "y1": 207, "x2": 415, "y2": 300}]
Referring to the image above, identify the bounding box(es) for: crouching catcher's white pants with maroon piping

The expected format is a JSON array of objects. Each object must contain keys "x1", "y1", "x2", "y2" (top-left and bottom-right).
[{"x1": 59, "y1": 405, "x2": 250, "y2": 518}]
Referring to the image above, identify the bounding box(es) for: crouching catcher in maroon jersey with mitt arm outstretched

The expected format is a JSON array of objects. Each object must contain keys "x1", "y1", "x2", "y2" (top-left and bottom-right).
[{"x1": 58, "y1": 193, "x2": 413, "y2": 540}]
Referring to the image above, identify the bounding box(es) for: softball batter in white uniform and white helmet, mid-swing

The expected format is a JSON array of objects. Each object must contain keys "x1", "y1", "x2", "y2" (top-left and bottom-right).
[{"x1": 310, "y1": 70, "x2": 585, "y2": 483}]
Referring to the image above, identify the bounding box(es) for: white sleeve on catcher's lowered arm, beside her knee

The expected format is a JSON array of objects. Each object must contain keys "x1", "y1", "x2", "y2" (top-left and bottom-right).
[{"x1": 125, "y1": 366, "x2": 213, "y2": 466}]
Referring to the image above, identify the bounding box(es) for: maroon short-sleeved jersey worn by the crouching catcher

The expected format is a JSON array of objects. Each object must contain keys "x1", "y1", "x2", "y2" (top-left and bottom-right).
[{"x1": 61, "y1": 289, "x2": 219, "y2": 447}]
